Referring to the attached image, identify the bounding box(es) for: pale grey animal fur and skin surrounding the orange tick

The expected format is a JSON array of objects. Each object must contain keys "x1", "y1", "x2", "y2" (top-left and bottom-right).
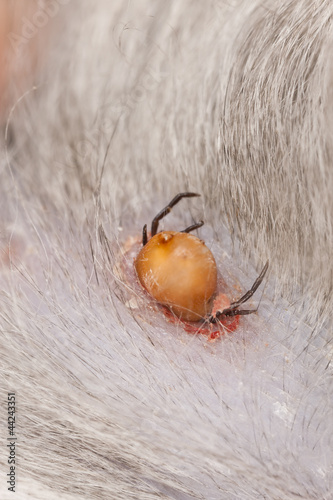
[{"x1": 0, "y1": 0, "x2": 333, "y2": 500}]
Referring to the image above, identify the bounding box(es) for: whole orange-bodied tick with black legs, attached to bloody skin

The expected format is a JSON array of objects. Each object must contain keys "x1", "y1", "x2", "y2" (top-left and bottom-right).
[{"x1": 134, "y1": 192, "x2": 268, "y2": 323}]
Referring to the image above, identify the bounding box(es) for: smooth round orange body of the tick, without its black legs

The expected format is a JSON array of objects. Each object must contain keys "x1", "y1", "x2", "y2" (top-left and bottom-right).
[{"x1": 135, "y1": 231, "x2": 217, "y2": 321}]
